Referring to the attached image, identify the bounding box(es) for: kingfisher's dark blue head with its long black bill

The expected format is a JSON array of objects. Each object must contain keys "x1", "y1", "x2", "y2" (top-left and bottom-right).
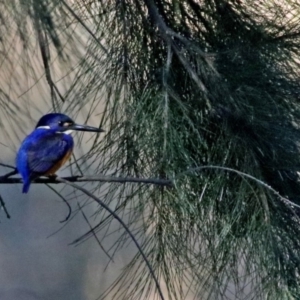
[{"x1": 35, "y1": 113, "x2": 104, "y2": 133}]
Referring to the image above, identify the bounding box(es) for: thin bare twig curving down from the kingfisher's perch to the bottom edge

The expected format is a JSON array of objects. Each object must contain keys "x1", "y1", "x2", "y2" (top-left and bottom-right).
[{"x1": 56, "y1": 177, "x2": 164, "y2": 300}]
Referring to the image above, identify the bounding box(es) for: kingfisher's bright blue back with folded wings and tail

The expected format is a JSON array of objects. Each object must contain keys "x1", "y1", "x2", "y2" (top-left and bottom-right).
[{"x1": 16, "y1": 128, "x2": 74, "y2": 193}]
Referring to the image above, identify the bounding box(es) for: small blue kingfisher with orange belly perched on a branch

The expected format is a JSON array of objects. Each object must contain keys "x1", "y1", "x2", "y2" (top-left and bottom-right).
[{"x1": 16, "y1": 113, "x2": 104, "y2": 193}]
